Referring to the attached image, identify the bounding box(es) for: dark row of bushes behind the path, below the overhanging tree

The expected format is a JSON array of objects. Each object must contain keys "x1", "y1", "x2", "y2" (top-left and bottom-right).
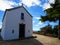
[{"x1": 40, "y1": 24, "x2": 59, "y2": 36}]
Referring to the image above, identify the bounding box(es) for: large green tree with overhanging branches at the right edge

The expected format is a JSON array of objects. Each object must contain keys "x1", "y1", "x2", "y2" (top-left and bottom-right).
[{"x1": 40, "y1": 0, "x2": 60, "y2": 39}]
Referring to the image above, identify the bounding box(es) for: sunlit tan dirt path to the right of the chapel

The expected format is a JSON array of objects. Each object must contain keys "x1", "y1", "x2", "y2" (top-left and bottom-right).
[{"x1": 34, "y1": 34, "x2": 60, "y2": 45}]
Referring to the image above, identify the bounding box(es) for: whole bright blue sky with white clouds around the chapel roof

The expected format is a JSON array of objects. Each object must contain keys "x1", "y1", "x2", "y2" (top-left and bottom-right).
[{"x1": 0, "y1": 0, "x2": 58, "y2": 31}]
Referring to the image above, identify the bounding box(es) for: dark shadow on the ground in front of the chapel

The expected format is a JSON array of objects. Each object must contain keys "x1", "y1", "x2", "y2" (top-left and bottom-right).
[{"x1": 0, "y1": 38, "x2": 43, "y2": 45}]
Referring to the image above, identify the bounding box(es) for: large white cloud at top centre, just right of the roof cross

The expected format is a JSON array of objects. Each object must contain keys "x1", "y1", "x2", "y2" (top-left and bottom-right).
[{"x1": 20, "y1": 0, "x2": 41, "y2": 7}]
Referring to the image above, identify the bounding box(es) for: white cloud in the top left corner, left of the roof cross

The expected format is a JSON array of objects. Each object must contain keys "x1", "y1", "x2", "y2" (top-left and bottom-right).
[{"x1": 0, "y1": 0, "x2": 17, "y2": 11}]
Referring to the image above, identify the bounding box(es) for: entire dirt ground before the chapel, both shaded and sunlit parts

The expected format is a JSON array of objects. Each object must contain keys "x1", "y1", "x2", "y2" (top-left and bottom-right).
[{"x1": 0, "y1": 34, "x2": 60, "y2": 45}]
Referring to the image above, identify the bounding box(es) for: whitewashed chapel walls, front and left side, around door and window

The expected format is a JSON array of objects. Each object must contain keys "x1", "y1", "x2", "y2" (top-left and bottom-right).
[{"x1": 1, "y1": 7, "x2": 32, "y2": 40}]
